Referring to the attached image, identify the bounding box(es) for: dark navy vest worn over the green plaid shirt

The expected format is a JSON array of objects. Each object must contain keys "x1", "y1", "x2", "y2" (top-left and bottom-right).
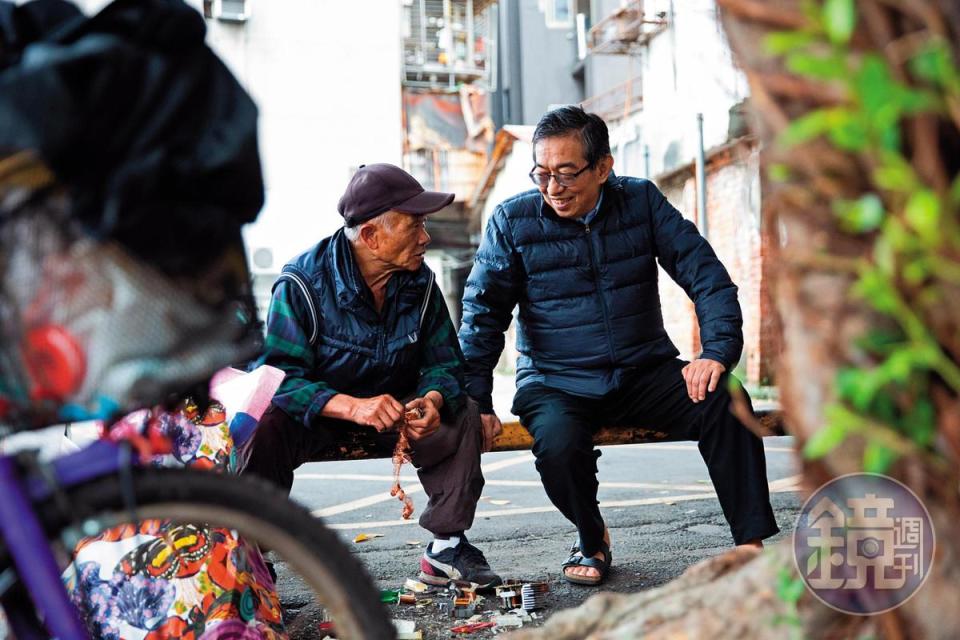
[{"x1": 274, "y1": 229, "x2": 434, "y2": 398}]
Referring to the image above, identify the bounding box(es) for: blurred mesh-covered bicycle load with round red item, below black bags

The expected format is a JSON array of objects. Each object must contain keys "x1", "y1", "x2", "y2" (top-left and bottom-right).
[{"x1": 0, "y1": 153, "x2": 256, "y2": 429}]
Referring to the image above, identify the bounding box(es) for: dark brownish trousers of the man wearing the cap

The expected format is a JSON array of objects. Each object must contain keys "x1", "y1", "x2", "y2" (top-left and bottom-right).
[{"x1": 243, "y1": 400, "x2": 484, "y2": 536}]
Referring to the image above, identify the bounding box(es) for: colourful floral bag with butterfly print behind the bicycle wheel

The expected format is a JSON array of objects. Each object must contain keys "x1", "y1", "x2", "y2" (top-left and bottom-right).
[{"x1": 64, "y1": 367, "x2": 286, "y2": 640}]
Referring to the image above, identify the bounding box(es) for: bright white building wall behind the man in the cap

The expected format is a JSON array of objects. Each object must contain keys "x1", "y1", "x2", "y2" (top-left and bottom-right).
[{"x1": 202, "y1": 0, "x2": 402, "y2": 271}]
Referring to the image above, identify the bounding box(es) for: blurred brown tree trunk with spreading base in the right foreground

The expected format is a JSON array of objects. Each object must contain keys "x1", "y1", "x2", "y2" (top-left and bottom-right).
[{"x1": 511, "y1": 0, "x2": 960, "y2": 640}]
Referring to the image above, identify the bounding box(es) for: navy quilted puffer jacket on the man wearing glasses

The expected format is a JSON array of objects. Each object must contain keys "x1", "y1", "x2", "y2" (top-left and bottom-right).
[{"x1": 459, "y1": 175, "x2": 743, "y2": 412}]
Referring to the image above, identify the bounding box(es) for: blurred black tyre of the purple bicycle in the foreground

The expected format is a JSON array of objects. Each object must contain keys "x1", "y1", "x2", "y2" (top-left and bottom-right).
[{"x1": 15, "y1": 468, "x2": 396, "y2": 640}]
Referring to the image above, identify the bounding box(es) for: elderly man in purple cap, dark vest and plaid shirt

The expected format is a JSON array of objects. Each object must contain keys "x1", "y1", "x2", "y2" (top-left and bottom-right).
[{"x1": 247, "y1": 164, "x2": 500, "y2": 587}]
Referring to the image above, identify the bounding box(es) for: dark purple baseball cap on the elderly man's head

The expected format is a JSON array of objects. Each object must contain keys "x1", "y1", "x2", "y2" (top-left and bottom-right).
[{"x1": 337, "y1": 163, "x2": 454, "y2": 227}]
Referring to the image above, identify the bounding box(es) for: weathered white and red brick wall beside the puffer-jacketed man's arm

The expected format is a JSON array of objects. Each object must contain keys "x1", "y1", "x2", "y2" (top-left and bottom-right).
[{"x1": 658, "y1": 142, "x2": 777, "y2": 384}]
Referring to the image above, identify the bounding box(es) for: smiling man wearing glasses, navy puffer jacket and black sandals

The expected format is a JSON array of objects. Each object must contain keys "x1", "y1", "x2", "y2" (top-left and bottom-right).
[{"x1": 459, "y1": 106, "x2": 779, "y2": 585}]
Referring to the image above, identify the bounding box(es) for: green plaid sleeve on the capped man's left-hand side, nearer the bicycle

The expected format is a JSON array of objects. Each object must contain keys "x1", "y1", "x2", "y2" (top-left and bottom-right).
[{"x1": 263, "y1": 282, "x2": 338, "y2": 427}]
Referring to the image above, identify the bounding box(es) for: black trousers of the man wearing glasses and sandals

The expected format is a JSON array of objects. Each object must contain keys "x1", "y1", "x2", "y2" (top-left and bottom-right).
[{"x1": 513, "y1": 360, "x2": 779, "y2": 556}]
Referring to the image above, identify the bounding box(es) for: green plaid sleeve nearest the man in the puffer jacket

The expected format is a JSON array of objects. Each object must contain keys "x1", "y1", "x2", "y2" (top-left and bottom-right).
[{"x1": 417, "y1": 284, "x2": 465, "y2": 415}]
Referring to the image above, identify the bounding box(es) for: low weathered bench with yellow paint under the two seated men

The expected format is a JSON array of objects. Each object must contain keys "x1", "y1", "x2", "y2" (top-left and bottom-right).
[{"x1": 311, "y1": 411, "x2": 786, "y2": 462}]
